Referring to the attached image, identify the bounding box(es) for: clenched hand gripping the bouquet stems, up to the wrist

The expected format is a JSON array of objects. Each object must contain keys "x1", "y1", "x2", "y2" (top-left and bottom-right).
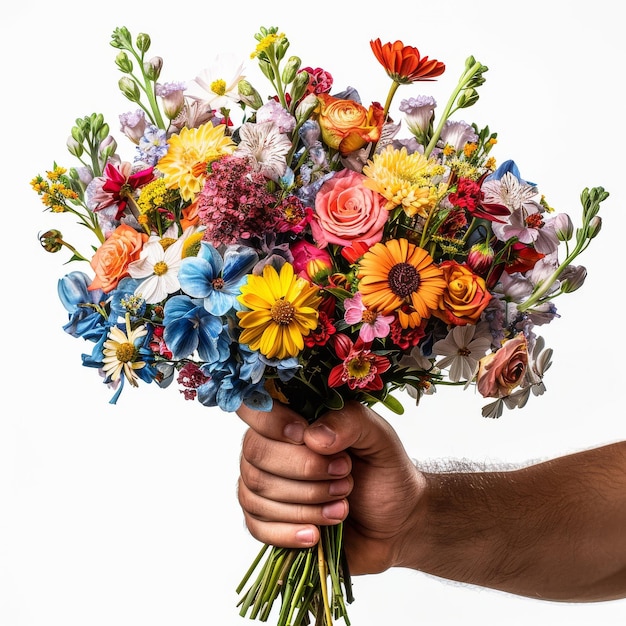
[{"x1": 238, "y1": 403, "x2": 425, "y2": 575}]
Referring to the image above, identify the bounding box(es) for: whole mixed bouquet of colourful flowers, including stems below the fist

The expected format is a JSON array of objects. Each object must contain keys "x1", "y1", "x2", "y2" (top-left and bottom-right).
[{"x1": 32, "y1": 27, "x2": 608, "y2": 626}]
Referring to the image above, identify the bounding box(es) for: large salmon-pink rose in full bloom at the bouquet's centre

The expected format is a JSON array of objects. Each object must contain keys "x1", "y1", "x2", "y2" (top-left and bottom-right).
[{"x1": 311, "y1": 170, "x2": 389, "y2": 248}]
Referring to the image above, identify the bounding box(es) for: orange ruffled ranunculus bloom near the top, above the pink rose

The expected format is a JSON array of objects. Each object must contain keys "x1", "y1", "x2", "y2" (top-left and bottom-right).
[{"x1": 316, "y1": 93, "x2": 385, "y2": 155}]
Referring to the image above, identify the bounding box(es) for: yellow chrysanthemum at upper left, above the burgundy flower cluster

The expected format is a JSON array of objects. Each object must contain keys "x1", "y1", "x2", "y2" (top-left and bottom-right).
[{"x1": 156, "y1": 122, "x2": 236, "y2": 200}]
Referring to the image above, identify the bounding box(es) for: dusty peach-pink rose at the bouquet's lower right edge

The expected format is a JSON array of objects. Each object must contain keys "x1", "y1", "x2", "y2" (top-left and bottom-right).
[{"x1": 476, "y1": 334, "x2": 528, "y2": 398}]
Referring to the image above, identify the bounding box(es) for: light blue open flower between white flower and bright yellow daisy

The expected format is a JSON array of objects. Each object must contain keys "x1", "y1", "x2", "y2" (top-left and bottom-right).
[{"x1": 178, "y1": 241, "x2": 258, "y2": 315}]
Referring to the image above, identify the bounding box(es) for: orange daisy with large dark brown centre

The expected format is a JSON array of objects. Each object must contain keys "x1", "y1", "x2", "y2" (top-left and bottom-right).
[{"x1": 357, "y1": 239, "x2": 446, "y2": 328}]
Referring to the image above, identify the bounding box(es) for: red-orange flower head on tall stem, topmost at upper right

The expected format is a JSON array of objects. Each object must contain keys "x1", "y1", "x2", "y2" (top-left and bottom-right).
[{"x1": 370, "y1": 39, "x2": 446, "y2": 84}]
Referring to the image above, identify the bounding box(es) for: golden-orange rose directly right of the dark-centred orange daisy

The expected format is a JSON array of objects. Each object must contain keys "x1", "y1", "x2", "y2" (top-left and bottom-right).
[{"x1": 433, "y1": 261, "x2": 491, "y2": 326}]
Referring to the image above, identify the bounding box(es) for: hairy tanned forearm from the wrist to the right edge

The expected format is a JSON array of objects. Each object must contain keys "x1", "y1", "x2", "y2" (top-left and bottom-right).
[{"x1": 398, "y1": 443, "x2": 626, "y2": 601}]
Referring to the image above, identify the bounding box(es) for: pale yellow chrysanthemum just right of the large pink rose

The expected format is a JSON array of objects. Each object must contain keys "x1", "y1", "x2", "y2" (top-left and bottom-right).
[{"x1": 363, "y1": 146, "x2": 442, "y2": 217}]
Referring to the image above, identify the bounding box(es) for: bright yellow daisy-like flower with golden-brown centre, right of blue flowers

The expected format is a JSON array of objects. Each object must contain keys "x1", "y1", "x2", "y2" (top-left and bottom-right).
[{"x1": 237, "y1": 263, "x2": 322, "y2": 359}]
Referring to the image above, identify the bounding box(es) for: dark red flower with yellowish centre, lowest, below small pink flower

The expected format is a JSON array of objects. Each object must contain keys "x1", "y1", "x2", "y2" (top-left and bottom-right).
[{"x1": 328, "y1": 333, "x2": 391, "y2": 391}]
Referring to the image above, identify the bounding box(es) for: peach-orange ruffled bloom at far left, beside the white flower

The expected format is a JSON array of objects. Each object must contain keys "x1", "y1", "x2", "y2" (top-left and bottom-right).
[{"x1": 88, "y1": 224, "x2": 148, "y2": 293}]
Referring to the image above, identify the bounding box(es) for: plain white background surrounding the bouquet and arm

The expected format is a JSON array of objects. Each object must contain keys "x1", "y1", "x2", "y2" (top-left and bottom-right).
[{"x1": 0, "y1": 0, "x2": 626, "y2": 626}]
